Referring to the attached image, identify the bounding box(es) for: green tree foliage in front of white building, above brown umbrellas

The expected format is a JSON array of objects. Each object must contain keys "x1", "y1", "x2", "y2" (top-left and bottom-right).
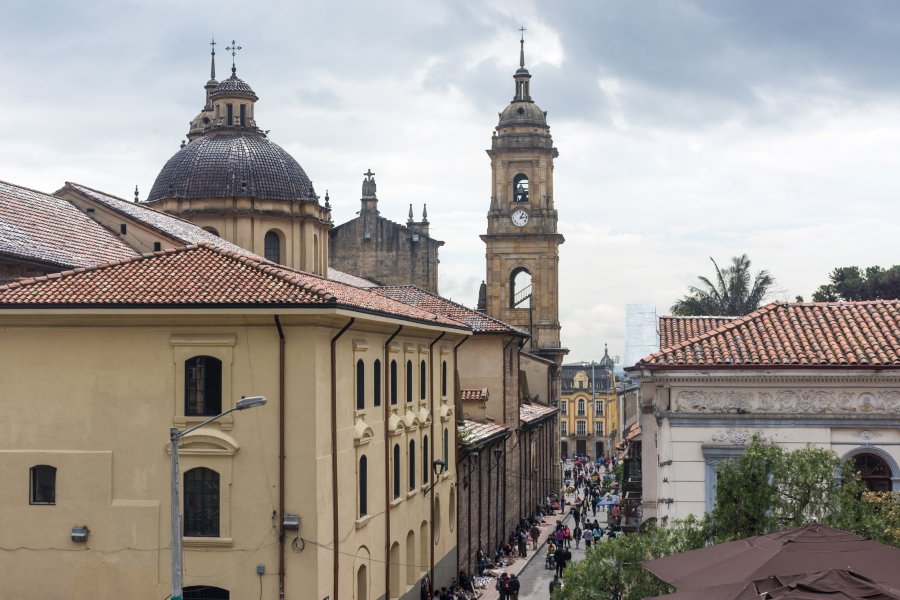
[{"x1": 553, "y1": 436, "x2": 900, "y2": 600}]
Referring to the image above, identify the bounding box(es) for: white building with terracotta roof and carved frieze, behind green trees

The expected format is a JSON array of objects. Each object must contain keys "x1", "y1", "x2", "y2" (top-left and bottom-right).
[{"x1": 631, "y1": 300, "x2": 900, "y2": 523}]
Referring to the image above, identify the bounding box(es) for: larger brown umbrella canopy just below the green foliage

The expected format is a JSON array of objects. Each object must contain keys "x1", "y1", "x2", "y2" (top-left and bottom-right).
[{"x1": 641, "y1": 523, "x2": 900, "y2": 588}]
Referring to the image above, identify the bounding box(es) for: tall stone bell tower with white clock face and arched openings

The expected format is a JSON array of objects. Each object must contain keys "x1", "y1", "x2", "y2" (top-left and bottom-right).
[{"x1": 481, "y1": 37, "x2": 568, "y2": 365}]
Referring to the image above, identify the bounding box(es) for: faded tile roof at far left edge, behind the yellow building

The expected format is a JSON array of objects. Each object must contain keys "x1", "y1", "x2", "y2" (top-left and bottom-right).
[{"x1": 0, "y1": 181, "x2": 138, "y2": 268}]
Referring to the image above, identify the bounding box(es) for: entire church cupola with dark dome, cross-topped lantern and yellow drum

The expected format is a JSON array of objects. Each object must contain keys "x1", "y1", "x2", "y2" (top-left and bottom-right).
[{"x1": 146, "y1": 41, "x2": 332, "y2": 275}]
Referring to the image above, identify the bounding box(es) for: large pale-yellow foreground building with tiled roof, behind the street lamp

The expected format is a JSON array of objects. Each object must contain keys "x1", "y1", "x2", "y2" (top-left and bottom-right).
[{"x1": 0, "y1": 246, "x2": 469, "y2": 599}]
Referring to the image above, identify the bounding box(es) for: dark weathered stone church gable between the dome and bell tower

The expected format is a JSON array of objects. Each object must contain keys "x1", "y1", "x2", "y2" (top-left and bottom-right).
[{"x1": 328, "y1": 169, "x2": 444, "y2": 293}]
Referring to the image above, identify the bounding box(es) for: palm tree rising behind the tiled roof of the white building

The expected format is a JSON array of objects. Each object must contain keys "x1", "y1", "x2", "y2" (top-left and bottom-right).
[{"x1": 672, "y1": 254, "x2": 775, "y2": 317}]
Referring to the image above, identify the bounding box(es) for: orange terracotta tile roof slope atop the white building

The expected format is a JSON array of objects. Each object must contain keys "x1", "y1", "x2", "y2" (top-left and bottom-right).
[{"x1": 634, "y1": 300, "x2": 900, "y2": 369}]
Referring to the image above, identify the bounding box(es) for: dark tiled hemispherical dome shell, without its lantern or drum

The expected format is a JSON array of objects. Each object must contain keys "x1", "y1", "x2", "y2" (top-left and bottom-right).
[{"x1": 147, "y1": 134, "x2": 316, "y2": 202}]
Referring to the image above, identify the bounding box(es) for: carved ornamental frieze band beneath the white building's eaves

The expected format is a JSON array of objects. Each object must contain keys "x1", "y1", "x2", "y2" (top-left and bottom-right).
[{"x1": 673, "y1": 389, "x2": 900, "y2": 414}]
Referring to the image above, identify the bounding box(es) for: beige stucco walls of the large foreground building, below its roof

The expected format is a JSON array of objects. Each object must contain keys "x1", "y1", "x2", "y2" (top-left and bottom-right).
[{"x1": 0, "y1": 311, "x2": 460, "y2": 599}]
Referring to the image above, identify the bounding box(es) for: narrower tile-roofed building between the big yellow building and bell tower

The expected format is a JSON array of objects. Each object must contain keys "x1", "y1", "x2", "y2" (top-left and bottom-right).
[{"x1": 373, "y1": 286, "x2": 560, "y2": 573}]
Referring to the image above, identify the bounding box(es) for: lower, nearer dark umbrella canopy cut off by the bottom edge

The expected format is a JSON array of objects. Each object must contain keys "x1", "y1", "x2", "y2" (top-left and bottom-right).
[{"x1": 649, "y1": 569, "x2": 900, "y2": 600}]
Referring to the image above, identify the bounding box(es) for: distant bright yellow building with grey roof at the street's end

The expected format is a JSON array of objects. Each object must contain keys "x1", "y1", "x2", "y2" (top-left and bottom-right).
[{"x1": 559, "y1": 350, "x2": 618, "y2": 460}]
